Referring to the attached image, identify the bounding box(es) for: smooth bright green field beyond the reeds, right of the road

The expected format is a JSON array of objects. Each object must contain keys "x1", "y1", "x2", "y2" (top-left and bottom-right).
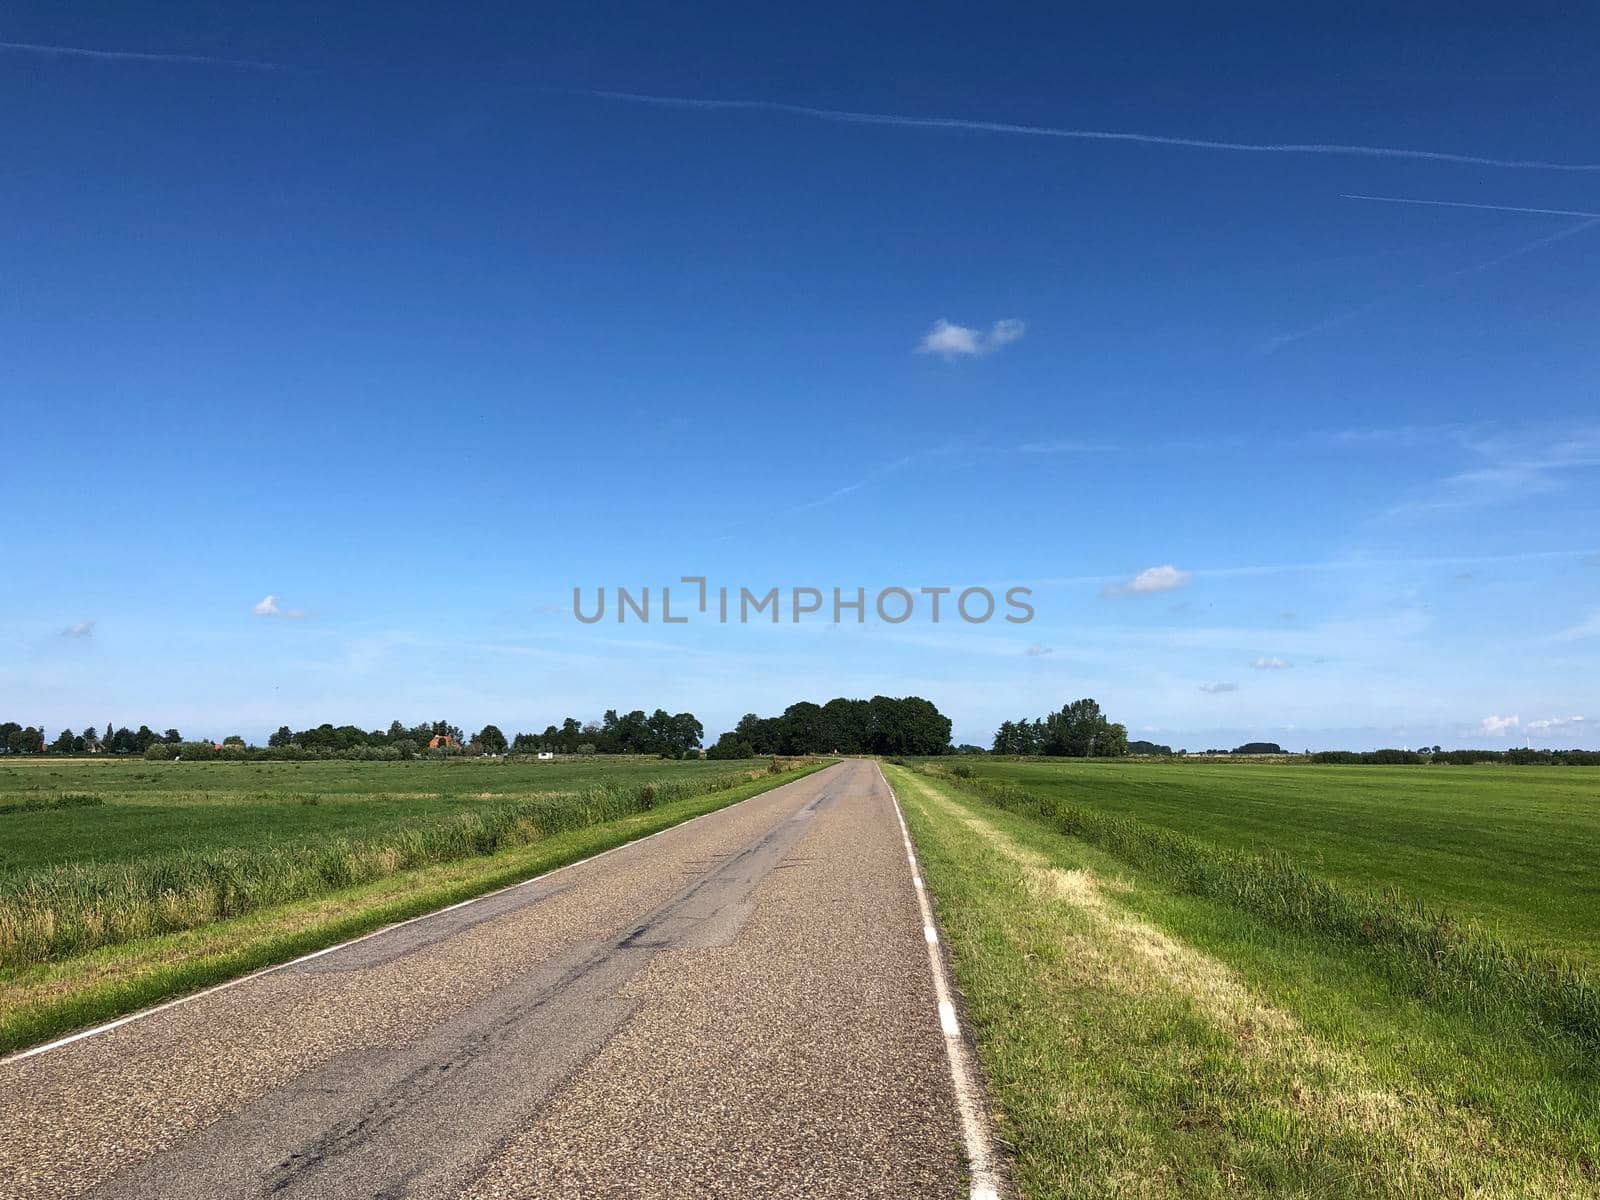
[{"x1": 953, "y1": 760, "x2": 1600, "y2": 966}]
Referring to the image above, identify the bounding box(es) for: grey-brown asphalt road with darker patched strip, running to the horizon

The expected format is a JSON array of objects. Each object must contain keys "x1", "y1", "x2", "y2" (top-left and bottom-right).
[{"x1": 0, "y1": 762, "x2": 970, "y2": 1200}]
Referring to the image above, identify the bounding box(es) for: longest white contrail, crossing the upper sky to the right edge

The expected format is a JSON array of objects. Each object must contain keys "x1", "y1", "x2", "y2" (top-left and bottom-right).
[{"x1": 572, "y1": 88, "x2": 1600, "y2": 171}]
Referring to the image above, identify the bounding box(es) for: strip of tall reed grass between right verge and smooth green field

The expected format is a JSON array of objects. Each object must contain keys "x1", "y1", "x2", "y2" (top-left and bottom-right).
[{"x1": 922, "y1": 765, "x2": 1600, "y2": 1067}]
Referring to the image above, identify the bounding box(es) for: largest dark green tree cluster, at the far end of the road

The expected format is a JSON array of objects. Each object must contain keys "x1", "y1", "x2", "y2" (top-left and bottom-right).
[{"x1": 706, "y1": 696, "x2": 950, "y2": 758}]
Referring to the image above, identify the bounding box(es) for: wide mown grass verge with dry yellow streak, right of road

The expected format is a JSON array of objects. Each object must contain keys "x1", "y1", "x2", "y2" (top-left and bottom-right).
[{"x1": 886, "y1": 766, "x2": 1600, "y2": 1200}]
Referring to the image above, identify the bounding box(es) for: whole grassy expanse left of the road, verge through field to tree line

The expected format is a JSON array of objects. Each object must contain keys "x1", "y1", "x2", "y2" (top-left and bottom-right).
[{"x1": 0, "y1": 760, "x2": 816, "y2": 1053}]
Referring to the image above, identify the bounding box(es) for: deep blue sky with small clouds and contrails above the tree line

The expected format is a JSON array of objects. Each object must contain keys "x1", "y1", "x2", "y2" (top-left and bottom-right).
[{"x1": 0, "y1": 3, "x2": 1600, "y2": 749}]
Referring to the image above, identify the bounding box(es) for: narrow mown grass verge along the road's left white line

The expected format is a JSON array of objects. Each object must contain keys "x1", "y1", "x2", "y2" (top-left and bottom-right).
[{"x1": 0, "y1": 763, "x2": 826, "y2": 1054}]
